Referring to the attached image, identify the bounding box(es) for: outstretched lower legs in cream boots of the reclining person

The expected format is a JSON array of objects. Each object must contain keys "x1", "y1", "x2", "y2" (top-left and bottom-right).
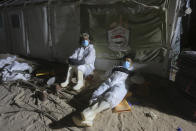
[{"x1": 72, "y1": 101, "x2": 110, "y2": 126}]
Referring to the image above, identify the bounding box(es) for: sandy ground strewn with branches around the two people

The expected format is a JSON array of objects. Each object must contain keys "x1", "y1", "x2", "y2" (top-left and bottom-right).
[{"x1": 0, "y1": 55, "x2": 196, "y2": 131}]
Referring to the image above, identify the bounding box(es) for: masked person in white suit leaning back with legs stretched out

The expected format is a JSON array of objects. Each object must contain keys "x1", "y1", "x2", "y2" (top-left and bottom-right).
[{"x1": 72, "y1": 58, "x2": 134, "y2": 126}]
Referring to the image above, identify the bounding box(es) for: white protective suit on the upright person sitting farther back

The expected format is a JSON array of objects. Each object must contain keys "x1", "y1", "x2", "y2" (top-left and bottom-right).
[{"x1": 69, "y1": 44, "x2": 96, "y2": 76}]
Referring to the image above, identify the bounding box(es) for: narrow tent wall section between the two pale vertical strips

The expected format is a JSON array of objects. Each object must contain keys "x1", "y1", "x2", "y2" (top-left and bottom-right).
[{"x1": 23, "y1": 6, "x2": 51, "y2": 59}]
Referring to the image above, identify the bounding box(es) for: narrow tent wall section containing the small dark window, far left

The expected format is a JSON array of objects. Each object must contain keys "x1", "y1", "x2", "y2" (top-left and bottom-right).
[{"x1": 6, "y1": 8, "x2": 27, "y2": 55}]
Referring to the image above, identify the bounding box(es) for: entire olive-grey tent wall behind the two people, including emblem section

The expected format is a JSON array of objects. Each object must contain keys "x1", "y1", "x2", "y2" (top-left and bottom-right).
[{"x1": 0, "y1": 0, "x2": 185, "y2": 74}]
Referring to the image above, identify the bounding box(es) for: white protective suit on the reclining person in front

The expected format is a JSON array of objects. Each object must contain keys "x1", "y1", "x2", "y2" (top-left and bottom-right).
[{"x1": 90, "y1": 66, "x2": 133, "y2": 108}]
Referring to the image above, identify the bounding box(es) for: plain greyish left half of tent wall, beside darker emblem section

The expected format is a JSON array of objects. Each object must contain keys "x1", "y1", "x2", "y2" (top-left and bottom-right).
[{"x1": 0, "y1": 0, "x2": 80, "y2": 62}]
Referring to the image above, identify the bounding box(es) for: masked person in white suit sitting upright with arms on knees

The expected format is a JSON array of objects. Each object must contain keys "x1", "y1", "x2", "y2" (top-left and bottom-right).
[{"x1": 61, "y1": 33, "x2": 96, "y2": 91}]
